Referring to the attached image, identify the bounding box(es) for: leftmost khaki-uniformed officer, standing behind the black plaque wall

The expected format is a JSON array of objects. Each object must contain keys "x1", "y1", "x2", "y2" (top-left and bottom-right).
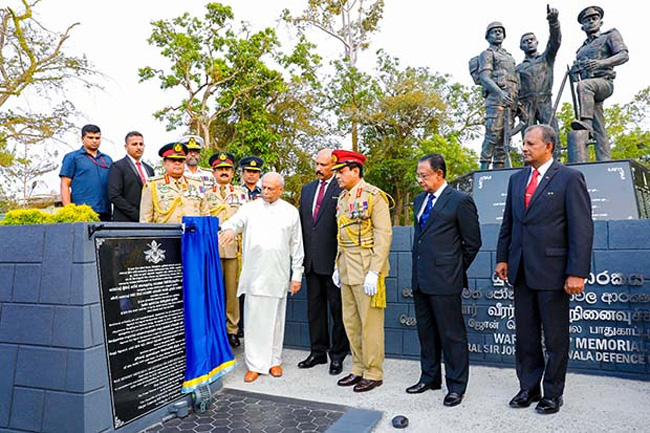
[{"x1": 140, "y1": 143, "x2": 210, "y2": 224}]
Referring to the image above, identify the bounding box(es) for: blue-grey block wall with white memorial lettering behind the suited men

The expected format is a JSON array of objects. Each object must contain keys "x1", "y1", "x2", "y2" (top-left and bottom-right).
[{"x1": 285, "y1": 220, "x2": 650, "y2": 380}]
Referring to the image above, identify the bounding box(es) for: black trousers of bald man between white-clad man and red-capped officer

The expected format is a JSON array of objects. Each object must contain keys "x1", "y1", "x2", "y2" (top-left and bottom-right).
[{"x1": 305, "y1": 271, "x2": 350, "y2": 361}]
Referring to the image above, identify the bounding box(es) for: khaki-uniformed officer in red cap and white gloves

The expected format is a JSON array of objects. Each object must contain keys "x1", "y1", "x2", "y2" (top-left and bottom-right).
[{"x1": 332, "y1": 150, "x2": 393, "y2": 392}]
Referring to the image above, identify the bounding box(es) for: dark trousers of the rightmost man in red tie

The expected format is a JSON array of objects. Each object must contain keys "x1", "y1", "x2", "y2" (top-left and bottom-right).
[{"x1": 515, "y1": 265, "x2": 569, "y2": 398}]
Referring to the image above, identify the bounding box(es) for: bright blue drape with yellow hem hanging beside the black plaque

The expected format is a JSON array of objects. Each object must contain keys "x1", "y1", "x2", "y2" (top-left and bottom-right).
[{"x1": 181, "y1": 216, "x2": 237, "y2": 393}]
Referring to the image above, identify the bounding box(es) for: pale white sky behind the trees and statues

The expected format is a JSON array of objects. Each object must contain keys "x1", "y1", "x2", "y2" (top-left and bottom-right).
[{"x1": 8, "y1": 0, "x2": 650, "y2": 192}]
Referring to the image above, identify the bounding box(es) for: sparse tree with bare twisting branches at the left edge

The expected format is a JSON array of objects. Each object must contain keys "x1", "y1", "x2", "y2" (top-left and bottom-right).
[{"x1": 0, "y1": 0, "x2": 97, "y2": 206}]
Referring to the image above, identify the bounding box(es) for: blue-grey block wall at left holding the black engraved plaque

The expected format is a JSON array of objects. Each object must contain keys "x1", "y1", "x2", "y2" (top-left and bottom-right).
[{"x1": 0, "y1": 223, "x2": 200, "y2": 433}]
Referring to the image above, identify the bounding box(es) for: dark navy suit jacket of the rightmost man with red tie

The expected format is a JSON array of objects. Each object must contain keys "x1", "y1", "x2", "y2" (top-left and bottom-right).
[{"x1": 497, "y1": 162, "x2": 594, "y2": 290}]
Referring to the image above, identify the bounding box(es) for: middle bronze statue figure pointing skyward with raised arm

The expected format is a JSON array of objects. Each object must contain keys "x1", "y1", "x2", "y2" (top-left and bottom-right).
[{"x1": 517, "y1": 6, "x2": 562, "y2": 160}]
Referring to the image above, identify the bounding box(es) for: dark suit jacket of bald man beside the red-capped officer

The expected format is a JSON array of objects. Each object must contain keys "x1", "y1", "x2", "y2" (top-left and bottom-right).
[{"x1": 299, "y1": 178, "x2": 341, "y2": 275}]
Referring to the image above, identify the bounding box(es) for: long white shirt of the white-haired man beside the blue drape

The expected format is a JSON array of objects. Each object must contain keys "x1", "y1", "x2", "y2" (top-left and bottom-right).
[{"x1": 222, "y1": 199, "x2": 305, "y2": 298}]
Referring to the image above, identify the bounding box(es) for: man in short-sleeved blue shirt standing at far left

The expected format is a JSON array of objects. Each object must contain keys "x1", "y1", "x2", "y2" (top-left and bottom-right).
[{"x1": 59, "y1": 124, "x2": 113, "y2": 221}]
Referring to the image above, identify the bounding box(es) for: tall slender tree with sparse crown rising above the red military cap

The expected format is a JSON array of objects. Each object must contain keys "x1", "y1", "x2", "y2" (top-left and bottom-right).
[{"x1": 283, "y1": 0, "x2": 384, "y2": 151}]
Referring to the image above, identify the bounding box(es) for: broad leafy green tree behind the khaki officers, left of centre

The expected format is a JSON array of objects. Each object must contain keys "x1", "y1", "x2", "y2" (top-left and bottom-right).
[{"x1": 139, "y1": 3, "x2": 312, "y2": 150}]
